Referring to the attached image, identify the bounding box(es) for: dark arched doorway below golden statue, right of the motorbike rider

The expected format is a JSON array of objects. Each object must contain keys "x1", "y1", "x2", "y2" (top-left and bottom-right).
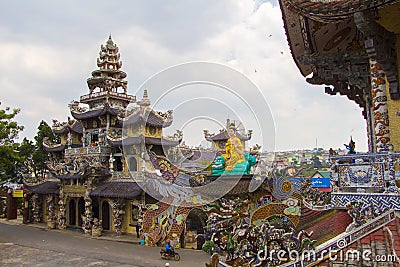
[{"x1": 181, "y1": 208, "x2": 207, "y2": 250}]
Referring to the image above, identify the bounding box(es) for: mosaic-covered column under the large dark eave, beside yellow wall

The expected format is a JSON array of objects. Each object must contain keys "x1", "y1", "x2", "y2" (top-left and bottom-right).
[{"x1": 369, "y1": 58, "x2": 391, "y2": 152}]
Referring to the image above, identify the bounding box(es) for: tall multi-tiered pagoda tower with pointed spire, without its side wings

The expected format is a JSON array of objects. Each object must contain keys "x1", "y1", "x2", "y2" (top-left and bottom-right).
[{"x1": 38, "y1": 36, "x2": 143, "y2": 234}]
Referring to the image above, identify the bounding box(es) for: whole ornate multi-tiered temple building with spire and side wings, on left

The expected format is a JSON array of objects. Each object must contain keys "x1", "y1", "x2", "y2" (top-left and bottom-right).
[{"x1": 25, "y1": 36, "x2": 188, "y2": 239}]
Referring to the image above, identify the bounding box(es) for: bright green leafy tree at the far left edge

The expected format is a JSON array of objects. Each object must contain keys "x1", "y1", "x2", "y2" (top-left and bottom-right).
[{"x1": 0, "y1": 103, "x2": 24, "y2": 182}]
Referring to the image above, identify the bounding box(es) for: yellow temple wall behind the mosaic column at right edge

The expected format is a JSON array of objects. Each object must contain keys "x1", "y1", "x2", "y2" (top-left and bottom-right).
[{"x1": 386, "y1": 34, "x2": 400, "y2": 151}]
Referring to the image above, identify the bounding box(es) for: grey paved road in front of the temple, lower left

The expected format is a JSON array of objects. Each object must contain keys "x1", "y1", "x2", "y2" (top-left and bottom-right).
[{"x1": 0, "y1": 220, "x2": 209, "y2": 267}]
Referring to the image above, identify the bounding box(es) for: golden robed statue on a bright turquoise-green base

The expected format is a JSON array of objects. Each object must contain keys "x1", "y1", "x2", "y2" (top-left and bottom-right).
[{"x1": 212, "y1": 124, "x2": 257, "y2": 176}]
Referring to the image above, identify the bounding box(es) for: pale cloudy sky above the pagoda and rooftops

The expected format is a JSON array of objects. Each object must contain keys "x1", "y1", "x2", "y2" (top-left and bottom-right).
[{"x1": 0, "y1": 0, "x2": 367, "y2": 151}]
